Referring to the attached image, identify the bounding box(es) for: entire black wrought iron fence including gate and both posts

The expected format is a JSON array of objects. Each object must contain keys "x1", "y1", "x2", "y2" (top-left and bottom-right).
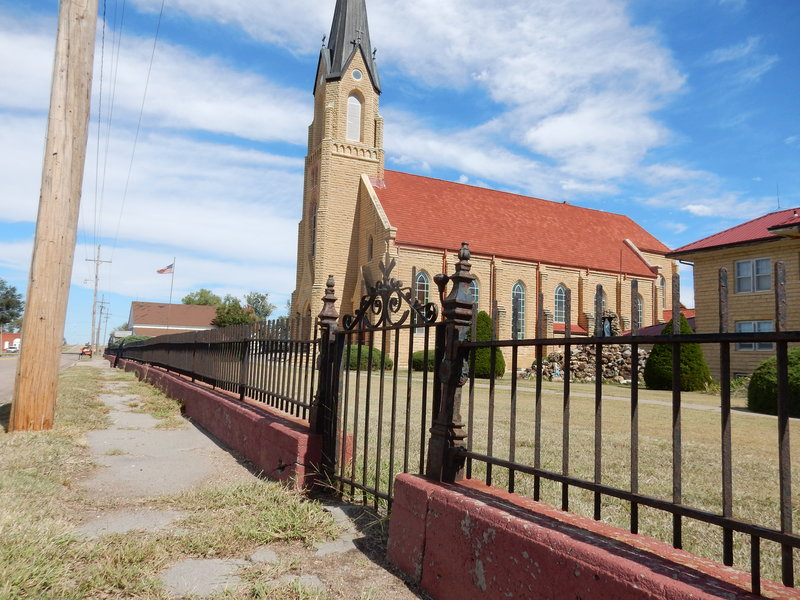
[{"x1": 115, "y1": 245, "x2": 800, "y2": 594}]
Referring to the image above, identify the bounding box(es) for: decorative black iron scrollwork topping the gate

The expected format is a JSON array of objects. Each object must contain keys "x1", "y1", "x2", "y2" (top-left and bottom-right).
[{"x1": 342, "y1": 253, "x2": 439, "y2": 331}]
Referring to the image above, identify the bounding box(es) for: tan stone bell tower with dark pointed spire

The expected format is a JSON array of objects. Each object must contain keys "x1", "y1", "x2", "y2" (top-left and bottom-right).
[{"x1": 291, "y1": 0, "x2": 384, "y2": 318}]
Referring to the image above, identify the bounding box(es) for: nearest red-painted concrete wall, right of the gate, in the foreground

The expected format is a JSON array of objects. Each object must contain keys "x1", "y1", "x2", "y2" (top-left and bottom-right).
[{"x1": 388, "y1": 475, "x2": 800, "y2": 600}]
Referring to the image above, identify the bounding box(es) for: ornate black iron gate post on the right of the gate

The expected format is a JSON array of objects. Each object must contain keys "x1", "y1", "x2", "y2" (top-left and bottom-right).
[{"x1": 425, "y1": 242, "x2": 475, "y2": 483}]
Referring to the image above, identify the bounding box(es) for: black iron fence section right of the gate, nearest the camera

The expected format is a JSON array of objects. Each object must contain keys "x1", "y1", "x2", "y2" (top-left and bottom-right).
[{"x1": 450, "y1": 253, "x2": 800, "y2": 594}]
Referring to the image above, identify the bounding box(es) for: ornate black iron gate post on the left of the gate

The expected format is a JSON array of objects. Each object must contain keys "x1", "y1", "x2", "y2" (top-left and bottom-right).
[{"x1": 309, "y1": 275, "x2": 344, "y2": 477}]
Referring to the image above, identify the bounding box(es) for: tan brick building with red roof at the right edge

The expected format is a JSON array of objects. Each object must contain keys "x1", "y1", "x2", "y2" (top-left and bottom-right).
[{"x1": 669, "y1": 208, "x2": 800, "y2": 378}]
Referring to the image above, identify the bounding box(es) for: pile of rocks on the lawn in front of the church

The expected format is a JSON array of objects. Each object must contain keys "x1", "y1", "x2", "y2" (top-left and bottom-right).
[{"x1": 520, "y1": 345, "x2": 649, "y2": 383}]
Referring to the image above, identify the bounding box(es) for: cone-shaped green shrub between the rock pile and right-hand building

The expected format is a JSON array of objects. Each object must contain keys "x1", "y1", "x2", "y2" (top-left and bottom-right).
[{"x1": 644, "y1": 315, "x2": 711, "y2": 392}]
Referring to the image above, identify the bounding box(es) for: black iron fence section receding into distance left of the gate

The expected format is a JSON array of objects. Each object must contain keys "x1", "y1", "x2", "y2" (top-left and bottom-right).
[{"x1": 117, "y1": 318, "x2": 319, "y2": 420}]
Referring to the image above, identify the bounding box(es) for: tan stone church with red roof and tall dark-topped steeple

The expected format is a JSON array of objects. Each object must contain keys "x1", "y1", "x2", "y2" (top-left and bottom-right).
[{"x1": 292, "y1": 0, "x2": 676, "y2": 346}]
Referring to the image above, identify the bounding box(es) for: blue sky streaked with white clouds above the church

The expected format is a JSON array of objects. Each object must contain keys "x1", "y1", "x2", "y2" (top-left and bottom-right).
[{"x1": 0, "y1": 0, "x2": 800, "y2": 343}]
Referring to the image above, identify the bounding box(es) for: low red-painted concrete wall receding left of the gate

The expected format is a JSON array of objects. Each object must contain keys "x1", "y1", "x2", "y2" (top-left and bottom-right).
[{"x1": 107, "y1": 356, "x2": 322, "y2": 488}]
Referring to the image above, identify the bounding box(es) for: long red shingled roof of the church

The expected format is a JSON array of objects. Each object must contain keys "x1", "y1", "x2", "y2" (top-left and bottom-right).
[{"x1": 373, "y1": 171, "x2": 669, "y2": 277}]
